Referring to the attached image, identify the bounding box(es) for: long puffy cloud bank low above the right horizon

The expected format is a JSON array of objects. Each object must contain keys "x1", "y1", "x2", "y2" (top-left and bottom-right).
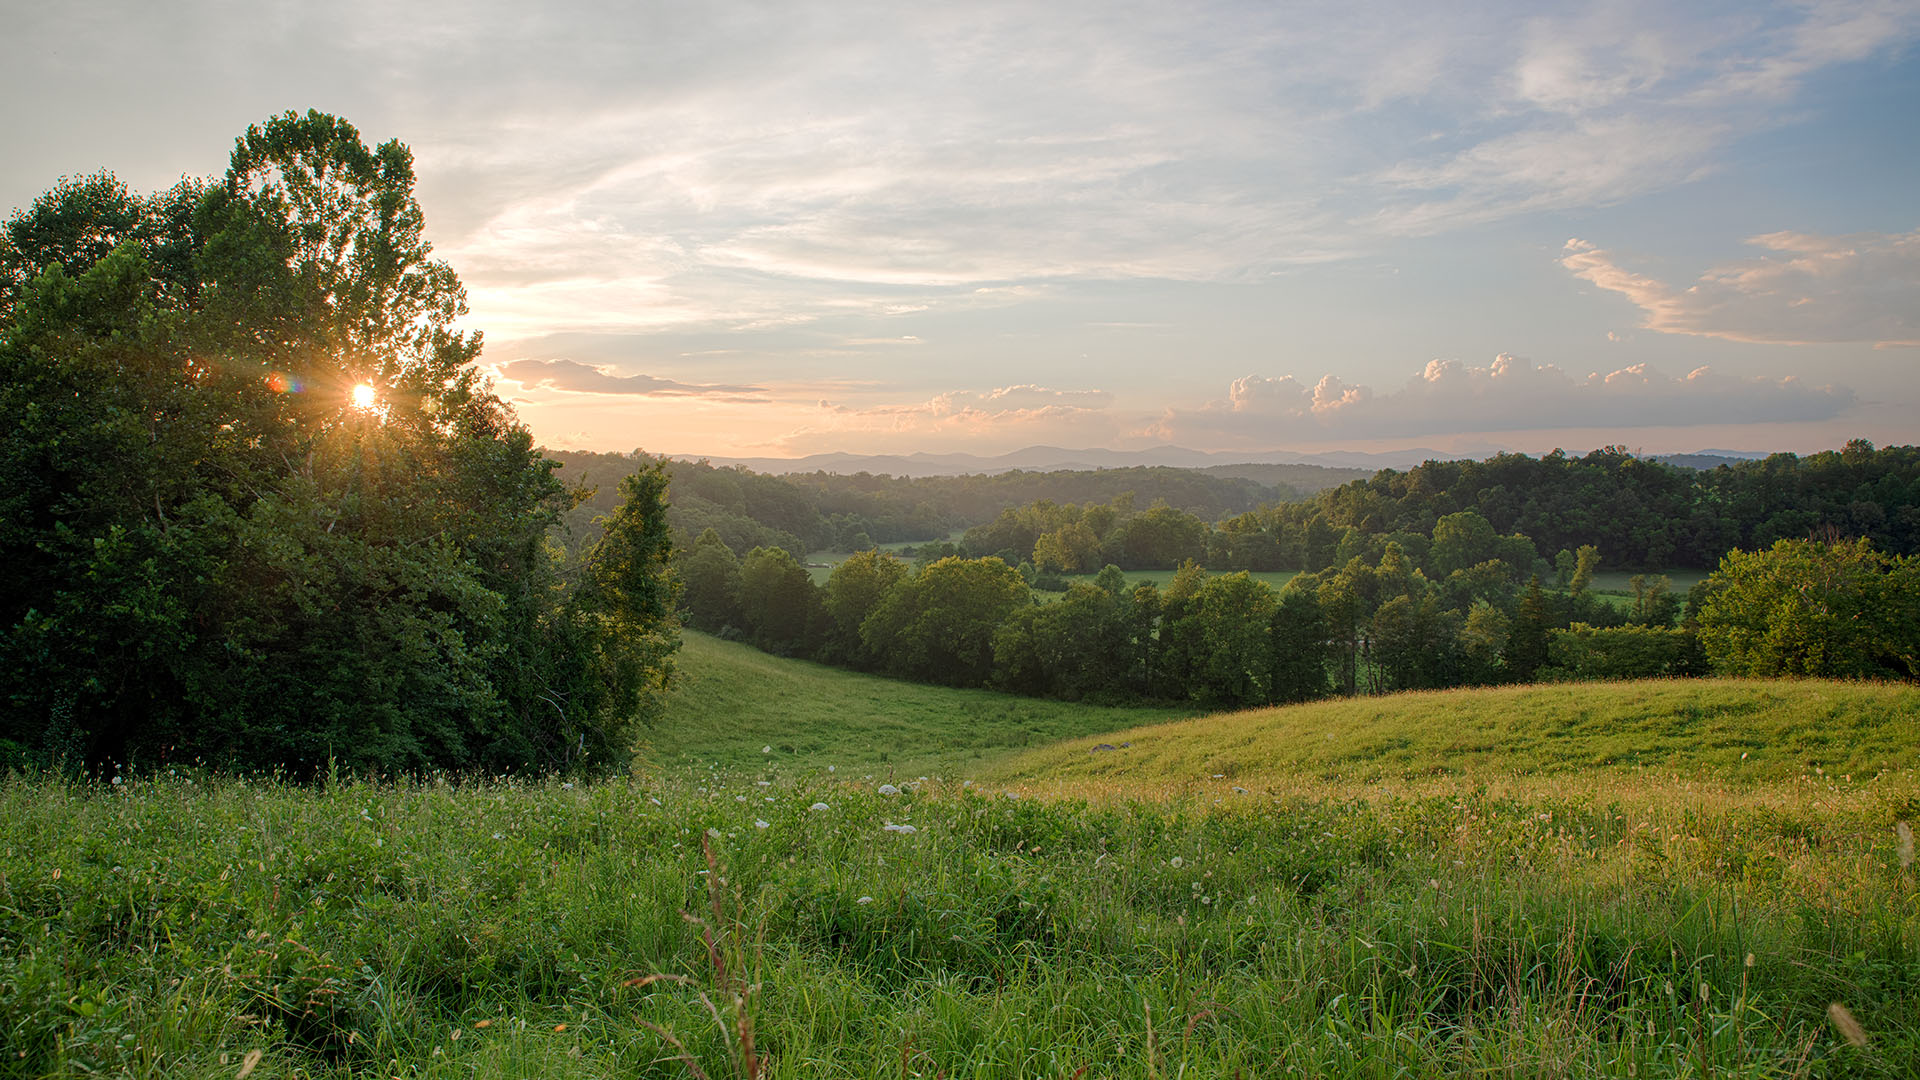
[{"x1": 1150, "y1": 354, "x2": 1855, "y2": 448}]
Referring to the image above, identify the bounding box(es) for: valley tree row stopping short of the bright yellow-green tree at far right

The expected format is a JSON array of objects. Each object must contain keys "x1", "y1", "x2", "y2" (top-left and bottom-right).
[{"x1": 682, "y1": 503, "x2": 1707, "y2": 705}]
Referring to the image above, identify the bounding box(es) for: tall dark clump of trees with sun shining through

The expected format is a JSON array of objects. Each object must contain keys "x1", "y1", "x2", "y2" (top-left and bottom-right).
[{"x1": 0, "y1": 113, "x2": 672, "y2": 773}]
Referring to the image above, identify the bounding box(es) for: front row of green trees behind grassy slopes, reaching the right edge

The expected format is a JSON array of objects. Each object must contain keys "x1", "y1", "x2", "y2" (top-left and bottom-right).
[{"x1": 680, "y1": 511, "x2": 1920, "y2": 707}]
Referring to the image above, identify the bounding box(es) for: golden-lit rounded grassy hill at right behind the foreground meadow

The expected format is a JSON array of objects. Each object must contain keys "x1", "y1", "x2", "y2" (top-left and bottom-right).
[{"x1": 993, "y1": 678, "x2": 1920, "y2": 788}]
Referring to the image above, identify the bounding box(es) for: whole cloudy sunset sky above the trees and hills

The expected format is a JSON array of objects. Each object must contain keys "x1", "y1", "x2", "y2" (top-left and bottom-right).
[{"x1": 0, "y1": 0, "x2": 1920, "y2": 457}]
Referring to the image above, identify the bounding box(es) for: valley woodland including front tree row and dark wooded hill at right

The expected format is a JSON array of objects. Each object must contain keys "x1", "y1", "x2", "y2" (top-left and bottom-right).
[{"x1": 678, "y1": 442, "x2": 1920, "y2": 707}]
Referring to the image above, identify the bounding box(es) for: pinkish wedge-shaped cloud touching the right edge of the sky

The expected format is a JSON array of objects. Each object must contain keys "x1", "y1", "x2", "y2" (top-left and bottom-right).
[{"x1": 1561, "y1": 229, "x2": 1920, "y2": 346}]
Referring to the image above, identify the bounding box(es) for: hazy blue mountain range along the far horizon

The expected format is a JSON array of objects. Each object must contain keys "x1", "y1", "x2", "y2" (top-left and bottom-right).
[{"x1": 674, "y1": 446, "x2": 1766, "y2": 477}]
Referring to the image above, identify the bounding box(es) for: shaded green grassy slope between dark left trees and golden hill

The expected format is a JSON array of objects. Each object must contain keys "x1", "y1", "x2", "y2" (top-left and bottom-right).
[{"x1": 647, "y1": 632, "x2": 1198, "y2": 776}]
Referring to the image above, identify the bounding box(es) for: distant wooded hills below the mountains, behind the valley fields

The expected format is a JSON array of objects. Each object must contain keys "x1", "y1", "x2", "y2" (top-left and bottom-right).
[{"x1": 549, "y1": 440, "x2": 1920, "y2": 573}]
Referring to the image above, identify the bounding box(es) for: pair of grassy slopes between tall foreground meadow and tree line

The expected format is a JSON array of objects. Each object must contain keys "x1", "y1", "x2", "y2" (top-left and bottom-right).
[{"x1": 647, "y1": 632, "x2": 1920, "y2": 790}]
